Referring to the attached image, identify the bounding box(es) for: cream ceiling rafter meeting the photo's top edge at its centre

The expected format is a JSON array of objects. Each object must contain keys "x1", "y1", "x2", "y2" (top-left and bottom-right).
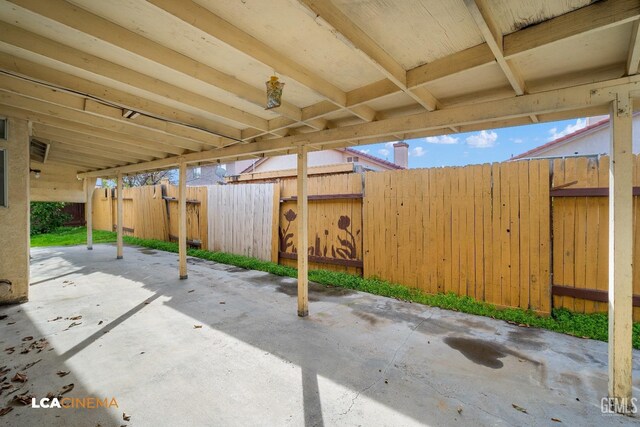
[{"x1": 299, "y1": 0, "x2": 438, "y2": 111}]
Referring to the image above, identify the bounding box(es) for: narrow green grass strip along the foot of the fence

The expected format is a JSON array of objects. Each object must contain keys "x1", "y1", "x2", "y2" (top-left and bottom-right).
[{"x1": 32, "y1": 227, "x2": 640, "y2": 349}]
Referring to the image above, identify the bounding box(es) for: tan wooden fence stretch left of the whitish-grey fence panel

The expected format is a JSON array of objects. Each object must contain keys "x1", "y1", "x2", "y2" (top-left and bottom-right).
[{"x1": 93, "y1": 184, "x2": 208, "y2": 248}]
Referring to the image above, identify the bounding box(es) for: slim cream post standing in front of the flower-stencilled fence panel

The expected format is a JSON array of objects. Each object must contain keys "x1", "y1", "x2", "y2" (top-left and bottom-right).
[{"x1": 298, "y1": 146, "x2": 309, "y2": 317}]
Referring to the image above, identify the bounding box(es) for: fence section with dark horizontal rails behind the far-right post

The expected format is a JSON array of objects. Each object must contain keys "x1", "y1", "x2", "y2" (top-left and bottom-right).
[{"x1": 551, "y1": 156, "x2": 640, "y2": 320}]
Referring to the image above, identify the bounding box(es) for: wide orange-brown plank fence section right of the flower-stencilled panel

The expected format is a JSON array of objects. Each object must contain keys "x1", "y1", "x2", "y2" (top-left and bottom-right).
[{"x1": 364, "y1": 160, "x2": 551, "y2": 312}]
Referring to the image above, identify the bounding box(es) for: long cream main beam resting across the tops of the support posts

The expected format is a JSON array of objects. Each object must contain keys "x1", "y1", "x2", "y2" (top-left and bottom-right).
[{"x1": 79, "y1": 76, "x2": 640, "y2": 177}]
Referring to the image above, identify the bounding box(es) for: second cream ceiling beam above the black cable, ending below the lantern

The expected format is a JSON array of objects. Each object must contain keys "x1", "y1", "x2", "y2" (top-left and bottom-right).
[{"x1": 0, "y1": 22, "x2": 268, "y2": 135}]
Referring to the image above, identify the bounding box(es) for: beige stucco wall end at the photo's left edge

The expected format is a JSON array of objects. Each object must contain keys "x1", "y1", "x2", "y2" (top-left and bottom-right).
[{"x1": 0, "y1": 119, "x2": 29, "y2": 304}]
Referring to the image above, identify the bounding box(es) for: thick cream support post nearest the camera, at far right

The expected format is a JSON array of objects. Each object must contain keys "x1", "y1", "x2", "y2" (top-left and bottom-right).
[{"x1": 609, "y1": 92, "x2": 633, "y2": 412}]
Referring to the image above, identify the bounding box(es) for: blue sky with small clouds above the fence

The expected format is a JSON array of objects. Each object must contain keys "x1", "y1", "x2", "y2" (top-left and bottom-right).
[{"x1": 354, "y1": 119, "x2": 587, "y2": 168}]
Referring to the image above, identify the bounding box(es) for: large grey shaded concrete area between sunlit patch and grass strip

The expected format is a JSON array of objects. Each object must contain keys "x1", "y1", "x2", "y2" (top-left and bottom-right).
[{"x1": 12, "y1": 245, "x2": 638, "y2": 426}]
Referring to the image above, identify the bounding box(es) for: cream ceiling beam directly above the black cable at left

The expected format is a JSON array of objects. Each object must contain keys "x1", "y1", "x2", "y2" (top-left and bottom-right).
[{"x1": 0, "y1": 52, "x2": 241, "y2": 139}]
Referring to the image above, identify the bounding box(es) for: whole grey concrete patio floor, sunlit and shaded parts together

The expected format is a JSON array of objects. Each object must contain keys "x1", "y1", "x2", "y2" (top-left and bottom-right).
[{"x1": 0, "y1": 245, "x2": 640, "y2": 426}]
